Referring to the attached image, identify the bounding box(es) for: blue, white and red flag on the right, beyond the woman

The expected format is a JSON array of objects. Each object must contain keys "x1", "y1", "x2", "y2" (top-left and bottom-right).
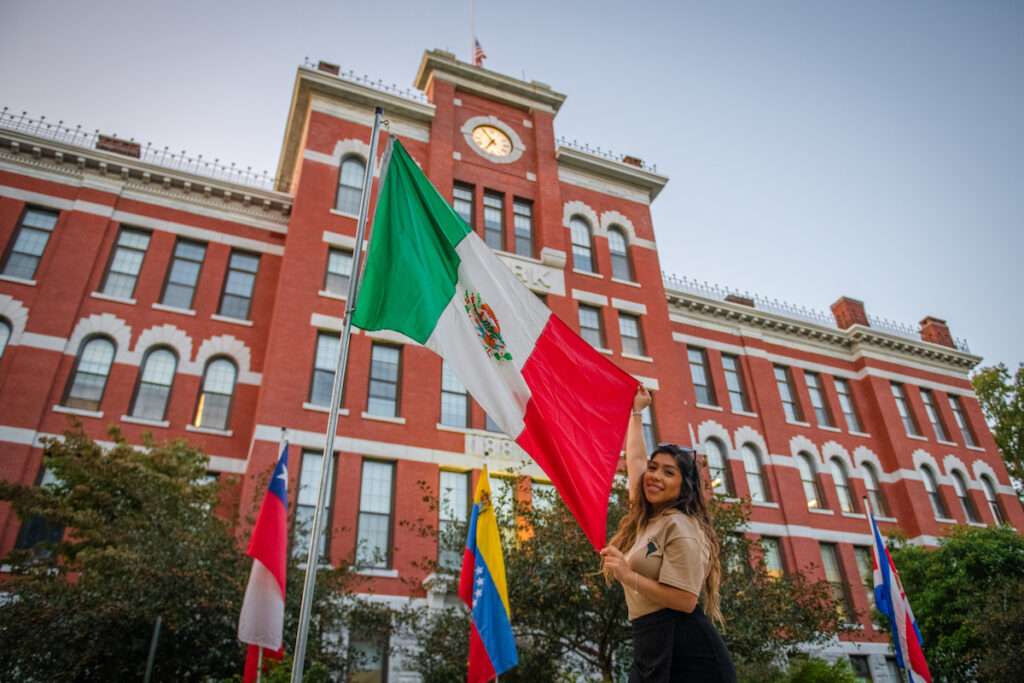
[{"x1": 867, "y1": 508, "x2": 932, "y2": 683}]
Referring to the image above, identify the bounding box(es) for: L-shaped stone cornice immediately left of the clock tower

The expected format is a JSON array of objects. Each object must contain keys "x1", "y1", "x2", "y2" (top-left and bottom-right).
[{"x1": 278, "y1": 67, "x2": 434, "y2": 191}]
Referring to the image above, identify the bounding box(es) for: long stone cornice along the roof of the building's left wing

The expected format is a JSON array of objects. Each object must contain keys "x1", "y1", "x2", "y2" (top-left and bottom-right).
[{"x1": 0, "y1": 129, "x2": 292, "y2": 222}]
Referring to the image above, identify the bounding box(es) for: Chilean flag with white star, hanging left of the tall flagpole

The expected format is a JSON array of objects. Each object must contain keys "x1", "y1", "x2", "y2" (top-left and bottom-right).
[{"x1": 239, "y1": 443, "x2": 288, "y2": 683}]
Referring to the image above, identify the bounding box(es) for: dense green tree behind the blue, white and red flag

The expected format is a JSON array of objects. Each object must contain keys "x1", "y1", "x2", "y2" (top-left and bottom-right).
[{"x1": 891, "y1": 525, "x2": 1024, "y2": 681}]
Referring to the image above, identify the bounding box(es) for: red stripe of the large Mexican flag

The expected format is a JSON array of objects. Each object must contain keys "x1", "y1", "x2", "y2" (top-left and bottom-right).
[{"x1": 516, "y1": 315, "x2": 637, "y2": 550}]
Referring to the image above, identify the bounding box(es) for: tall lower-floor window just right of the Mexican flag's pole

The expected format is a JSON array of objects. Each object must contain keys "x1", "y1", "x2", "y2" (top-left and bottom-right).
[{"x1": 355, "y1": 460, "x2": 394, "y2": 569}]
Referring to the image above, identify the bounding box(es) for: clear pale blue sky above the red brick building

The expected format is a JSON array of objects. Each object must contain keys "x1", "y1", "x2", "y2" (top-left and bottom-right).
[{"x1": 0, "y1": 0, "x2": 1024, "y2": 367}]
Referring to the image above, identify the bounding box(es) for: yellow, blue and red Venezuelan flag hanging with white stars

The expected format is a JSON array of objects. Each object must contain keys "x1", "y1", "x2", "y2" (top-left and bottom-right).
[{"x1": 459, "y1": 467, "x2": 519, "y2": 683}]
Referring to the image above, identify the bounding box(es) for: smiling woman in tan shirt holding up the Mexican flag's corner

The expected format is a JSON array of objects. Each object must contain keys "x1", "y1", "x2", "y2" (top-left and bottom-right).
[{"x1": 601, "y1": 386, "x2": 736, "y2": 683}]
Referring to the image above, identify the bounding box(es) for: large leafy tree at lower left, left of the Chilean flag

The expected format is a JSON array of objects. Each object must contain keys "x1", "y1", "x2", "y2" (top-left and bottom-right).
[{"x1": 0, "y1": 425, "x2": 246, "y2": 681}]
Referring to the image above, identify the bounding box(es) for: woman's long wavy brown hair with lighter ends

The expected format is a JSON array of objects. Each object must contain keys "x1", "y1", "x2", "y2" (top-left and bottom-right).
[{"x1": 604, "y1": 443, "x2": 724, "y2": 625}]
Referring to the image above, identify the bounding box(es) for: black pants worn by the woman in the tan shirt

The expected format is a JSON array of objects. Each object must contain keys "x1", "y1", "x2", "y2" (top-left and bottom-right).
[{"x1": 629, "y1": 605, "x2": 736, "y2": 683}]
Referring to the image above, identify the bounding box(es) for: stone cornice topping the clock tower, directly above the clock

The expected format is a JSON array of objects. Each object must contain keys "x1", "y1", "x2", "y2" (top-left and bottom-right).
[{"x1": 414, "y1": 50, "x2": 565, "y2": 114}]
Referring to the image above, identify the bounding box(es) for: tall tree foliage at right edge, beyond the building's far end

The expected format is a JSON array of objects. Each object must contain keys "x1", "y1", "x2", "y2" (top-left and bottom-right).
[{"x1": 971, "y1": 362, "x2": 1024, "y2": 500}]
